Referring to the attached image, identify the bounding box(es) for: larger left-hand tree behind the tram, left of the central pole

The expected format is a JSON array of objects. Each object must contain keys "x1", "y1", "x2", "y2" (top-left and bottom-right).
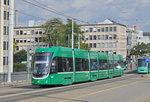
[{"x1": 42, "y1": 18, "x2": 64, "y2": 46}]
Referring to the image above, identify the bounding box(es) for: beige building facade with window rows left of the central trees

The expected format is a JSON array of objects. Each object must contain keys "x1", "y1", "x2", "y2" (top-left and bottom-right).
[{"x1": 14, "y1": 27, "x2": 47, "y2": 51}]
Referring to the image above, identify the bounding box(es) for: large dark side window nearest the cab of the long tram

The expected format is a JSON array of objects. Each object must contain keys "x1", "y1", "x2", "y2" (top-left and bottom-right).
[{"x1": 51, "y1": 57, "x2": 73, "y2": 72}]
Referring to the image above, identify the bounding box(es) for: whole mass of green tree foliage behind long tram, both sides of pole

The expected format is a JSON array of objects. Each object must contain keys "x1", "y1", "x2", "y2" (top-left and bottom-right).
[{"x1": 42, "y1": 18, "x2": 90, "y2": 50}]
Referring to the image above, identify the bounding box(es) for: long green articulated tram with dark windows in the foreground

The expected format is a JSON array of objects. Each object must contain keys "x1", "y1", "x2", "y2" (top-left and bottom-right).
[{"x1": 32, "y1": 47, "x2": 124, "y2": 85}]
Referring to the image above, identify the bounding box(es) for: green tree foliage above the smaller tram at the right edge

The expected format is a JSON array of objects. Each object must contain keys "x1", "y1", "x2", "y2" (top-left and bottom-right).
[{"x1": 130, "y1": 43, "x2": 150, "y2": 56}]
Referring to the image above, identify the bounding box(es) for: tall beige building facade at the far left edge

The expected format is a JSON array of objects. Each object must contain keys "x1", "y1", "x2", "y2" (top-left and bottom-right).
[{"x1": 0, "y1": 0, "x2": 9, "y2": 73}]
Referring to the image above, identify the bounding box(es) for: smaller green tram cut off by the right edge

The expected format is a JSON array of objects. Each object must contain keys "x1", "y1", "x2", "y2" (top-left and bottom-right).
[{"x1": 137, "y1": 57, "x2": 150, "y2": 73}]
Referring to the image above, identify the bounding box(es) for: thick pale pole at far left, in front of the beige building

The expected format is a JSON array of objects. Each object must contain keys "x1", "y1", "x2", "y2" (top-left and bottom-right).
[{"x1": 7, "y1": 0, "x2": 14, "y2": 83}]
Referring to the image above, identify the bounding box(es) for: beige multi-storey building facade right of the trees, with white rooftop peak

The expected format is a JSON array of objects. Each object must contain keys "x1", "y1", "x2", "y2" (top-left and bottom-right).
[{"x1": 81, "y1": 19, "x2": 127, "y2": 59}]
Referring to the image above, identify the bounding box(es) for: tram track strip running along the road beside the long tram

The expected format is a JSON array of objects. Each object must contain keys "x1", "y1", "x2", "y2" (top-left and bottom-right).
[{"x1": 0, "y1": 74, "x2": 138, "y2": 102}]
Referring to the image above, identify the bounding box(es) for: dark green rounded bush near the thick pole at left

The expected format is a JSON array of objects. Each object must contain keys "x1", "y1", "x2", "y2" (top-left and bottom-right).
[{"x1": 13, "y1": 50, "x2": 27, "y2": 63}]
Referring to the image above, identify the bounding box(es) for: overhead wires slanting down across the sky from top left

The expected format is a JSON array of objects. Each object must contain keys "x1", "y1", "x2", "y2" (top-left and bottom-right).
[{"x1": 23, "y1": 0, "x2": 88, "y2": 24}]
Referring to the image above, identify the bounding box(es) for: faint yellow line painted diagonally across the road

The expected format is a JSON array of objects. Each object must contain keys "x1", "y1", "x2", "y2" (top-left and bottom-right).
[{"x1": 58, "y1": 78, "x2": 150, "y2": 102}]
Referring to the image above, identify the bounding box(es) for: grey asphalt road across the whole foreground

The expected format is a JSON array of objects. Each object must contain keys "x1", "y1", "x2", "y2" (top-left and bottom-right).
[{"x1": 0, "y1": 73, "x2": 150, "y2": 102}]
